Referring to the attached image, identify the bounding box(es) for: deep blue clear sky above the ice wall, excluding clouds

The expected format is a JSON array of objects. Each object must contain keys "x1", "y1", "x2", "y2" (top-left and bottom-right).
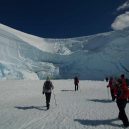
[{"x1": 0, "y1": 0, "x2": 127, "y2": 38}]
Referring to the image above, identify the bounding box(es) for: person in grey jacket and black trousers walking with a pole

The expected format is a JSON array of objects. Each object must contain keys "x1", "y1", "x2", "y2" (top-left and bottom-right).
[{"x1": 42, "y1": 77, "x2": 54, "y2": 109}]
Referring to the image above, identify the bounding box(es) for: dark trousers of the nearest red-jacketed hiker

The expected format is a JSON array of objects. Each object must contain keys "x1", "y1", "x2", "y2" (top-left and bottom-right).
[{"x1": 116, "y1": 99, "x2": 129, "y2": 126}]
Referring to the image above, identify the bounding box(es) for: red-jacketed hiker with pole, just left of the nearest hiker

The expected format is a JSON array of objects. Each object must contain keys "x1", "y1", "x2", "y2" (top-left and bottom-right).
[{"x1": 107, "y1": 77, "x2": 115, "y2": 101}]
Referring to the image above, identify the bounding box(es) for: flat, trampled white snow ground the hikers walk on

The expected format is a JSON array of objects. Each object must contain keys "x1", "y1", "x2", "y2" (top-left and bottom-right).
[{"x1": 0, "y1": 80, "x2": 129, "y2": 129}]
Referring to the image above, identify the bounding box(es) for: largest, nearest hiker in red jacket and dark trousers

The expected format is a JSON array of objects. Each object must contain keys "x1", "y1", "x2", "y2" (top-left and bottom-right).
[{"x1": 114, "y1": 78, "x2": 129, "y2": 127}]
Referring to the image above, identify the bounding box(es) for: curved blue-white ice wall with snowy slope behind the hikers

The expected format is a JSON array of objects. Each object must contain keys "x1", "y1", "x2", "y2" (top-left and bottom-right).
[{"x1": 0, "y1": 24, "x2": 129, "y2": 80}]
